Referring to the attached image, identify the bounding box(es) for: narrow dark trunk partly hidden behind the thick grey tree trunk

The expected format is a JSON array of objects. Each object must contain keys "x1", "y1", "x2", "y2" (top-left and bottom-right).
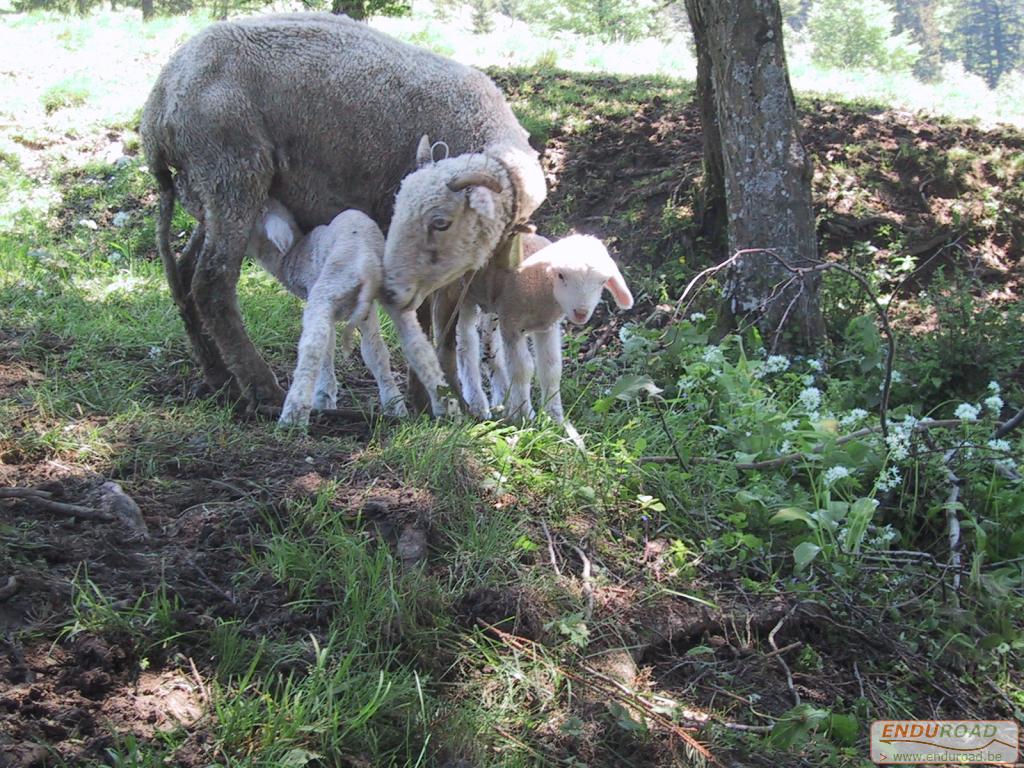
[{"x1": 686, "y1": 0, "x2": 726, "y2": 260}]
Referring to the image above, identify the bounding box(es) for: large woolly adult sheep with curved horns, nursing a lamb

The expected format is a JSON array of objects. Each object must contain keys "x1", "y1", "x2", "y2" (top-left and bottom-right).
[{"x1": 139, "y1": 13, "x2": 546, "y2": 414}]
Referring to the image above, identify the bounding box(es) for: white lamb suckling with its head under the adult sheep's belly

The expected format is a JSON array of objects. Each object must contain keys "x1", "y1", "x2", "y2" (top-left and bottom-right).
[{"x1": 246, "y1": 198, "x2": 432, "y2": 425}]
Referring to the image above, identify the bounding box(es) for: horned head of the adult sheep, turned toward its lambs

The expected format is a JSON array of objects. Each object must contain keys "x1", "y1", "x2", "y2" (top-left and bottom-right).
[{"x1": 381, "y1": 136, "x2": 513, "y2": 309}]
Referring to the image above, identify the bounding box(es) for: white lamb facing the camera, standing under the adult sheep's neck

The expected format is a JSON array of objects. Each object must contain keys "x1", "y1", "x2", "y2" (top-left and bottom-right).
[{"x1": 457, "y1": 234, "x2": 633, "y2": 424}]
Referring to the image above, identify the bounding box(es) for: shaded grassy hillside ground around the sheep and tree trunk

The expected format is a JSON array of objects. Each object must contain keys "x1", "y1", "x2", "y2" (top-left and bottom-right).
[{"x1": 0, "y1": 7, "x2": 1024, "y2": 768}]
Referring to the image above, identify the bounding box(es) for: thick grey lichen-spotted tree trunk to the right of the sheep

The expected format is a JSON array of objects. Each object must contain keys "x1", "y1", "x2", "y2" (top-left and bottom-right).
[{"x1": 687, "y1": 0, "x2": 824, "y2": 352}]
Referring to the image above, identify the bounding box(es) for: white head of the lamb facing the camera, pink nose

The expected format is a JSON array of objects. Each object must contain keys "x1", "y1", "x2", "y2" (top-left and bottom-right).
[{"x1": 539, "y1": 234, "x2": 633, "y2": 326}]
